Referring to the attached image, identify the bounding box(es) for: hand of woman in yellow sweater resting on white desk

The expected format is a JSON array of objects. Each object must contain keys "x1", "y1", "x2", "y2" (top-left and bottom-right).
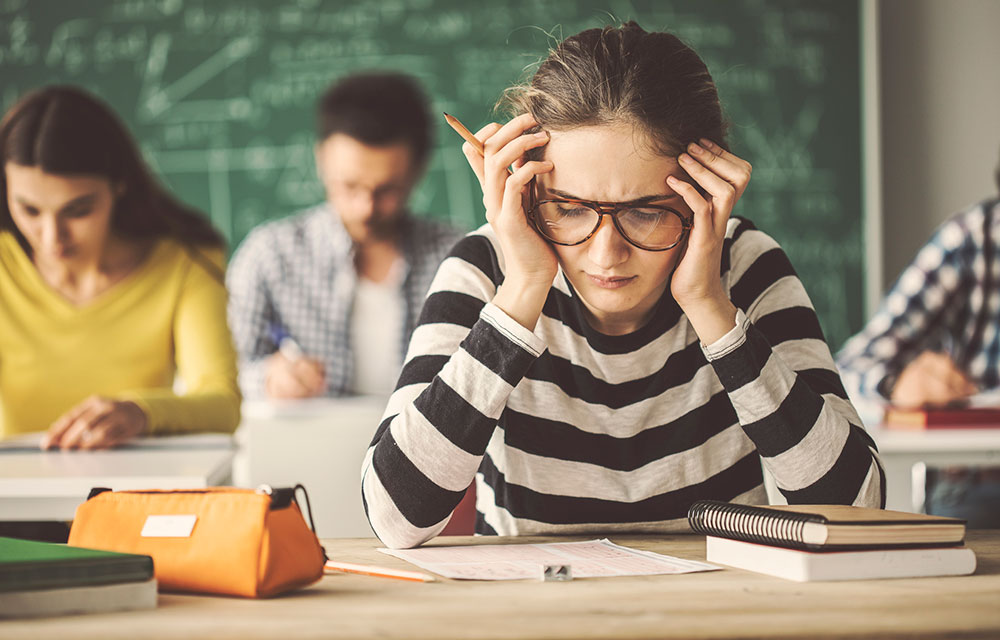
[{"x1": 42, "y1": 396, "x2": 149, "y2": 449}]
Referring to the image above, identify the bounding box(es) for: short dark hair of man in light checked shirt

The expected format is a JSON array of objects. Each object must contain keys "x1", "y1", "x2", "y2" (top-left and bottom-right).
[{"x1": 316, "y1": 73, "x2": 431, "y2": 168}]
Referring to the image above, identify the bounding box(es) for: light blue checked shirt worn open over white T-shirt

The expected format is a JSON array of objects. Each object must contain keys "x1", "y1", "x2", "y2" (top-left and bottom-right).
[{"x1": 226, "y1": 204, "x2": 461, "y2": 398}]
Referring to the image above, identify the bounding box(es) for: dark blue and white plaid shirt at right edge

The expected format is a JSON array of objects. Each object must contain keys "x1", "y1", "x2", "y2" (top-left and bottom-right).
[{"x1": 837, "y1": 200, "x2": 1000, "y2": 401}]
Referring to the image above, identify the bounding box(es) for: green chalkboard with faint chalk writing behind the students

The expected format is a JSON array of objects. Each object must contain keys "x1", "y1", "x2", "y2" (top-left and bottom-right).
[{"x1": 0, "y1": 0, "x2": 863, "y2": 346}]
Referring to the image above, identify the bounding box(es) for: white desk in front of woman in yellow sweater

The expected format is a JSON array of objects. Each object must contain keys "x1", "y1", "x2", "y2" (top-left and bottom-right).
[{"x1": 0, "y1": 434, "x2": 235, "y2": 521}]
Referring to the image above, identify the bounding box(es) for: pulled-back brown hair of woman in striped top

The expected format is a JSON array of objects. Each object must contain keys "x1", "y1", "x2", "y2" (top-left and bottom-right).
[{"x1": 497, "y1": 21, "x2": 727, "y2": 156}]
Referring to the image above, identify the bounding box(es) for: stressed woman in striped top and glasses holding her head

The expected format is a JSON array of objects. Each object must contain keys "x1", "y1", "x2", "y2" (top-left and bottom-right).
[{"x1": 363, "y1": 23, "x2": 884, "y2": 547}]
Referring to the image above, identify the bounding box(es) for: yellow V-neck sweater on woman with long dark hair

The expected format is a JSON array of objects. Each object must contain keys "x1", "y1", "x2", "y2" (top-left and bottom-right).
[{"x1": 0, "y1": 231, "x2": 240, "y2": 438}]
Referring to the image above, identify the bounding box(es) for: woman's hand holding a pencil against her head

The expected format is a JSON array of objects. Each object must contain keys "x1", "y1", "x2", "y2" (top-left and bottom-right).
[{"x1": 462, "y1": 114, "x2": 559, "y2": 329}]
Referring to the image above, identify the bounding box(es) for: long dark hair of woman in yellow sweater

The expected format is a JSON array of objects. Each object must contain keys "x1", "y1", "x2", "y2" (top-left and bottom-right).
[{"x1": 0, "y1": 86, "x2": 225, "y2": 247}]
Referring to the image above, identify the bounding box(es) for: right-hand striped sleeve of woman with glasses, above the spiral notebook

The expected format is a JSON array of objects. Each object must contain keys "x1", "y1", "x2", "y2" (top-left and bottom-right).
[{"x1": 704, "y1": 221, "x2": 885, "y2": 507}]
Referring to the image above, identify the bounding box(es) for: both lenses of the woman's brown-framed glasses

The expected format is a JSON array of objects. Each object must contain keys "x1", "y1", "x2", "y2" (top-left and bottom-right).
[{"x1": 535, "y1": 201, "x2": 684, "y2": 249}]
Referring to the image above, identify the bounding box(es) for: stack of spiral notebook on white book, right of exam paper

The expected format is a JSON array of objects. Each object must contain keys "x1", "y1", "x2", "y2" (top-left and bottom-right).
[{"x1": 688, "y1": 500, "x2": 976, "y2": 582}]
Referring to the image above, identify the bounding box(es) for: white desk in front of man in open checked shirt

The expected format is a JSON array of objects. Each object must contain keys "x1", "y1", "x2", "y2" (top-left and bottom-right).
[{"x1": 237, "y1": 396, "x2": 387, "y2": 538}]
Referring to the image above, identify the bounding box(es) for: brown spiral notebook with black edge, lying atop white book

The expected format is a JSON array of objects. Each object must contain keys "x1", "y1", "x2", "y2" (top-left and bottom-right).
[{"x1": 688, "y1": 500, "x2": 965, "y2": 551}]
